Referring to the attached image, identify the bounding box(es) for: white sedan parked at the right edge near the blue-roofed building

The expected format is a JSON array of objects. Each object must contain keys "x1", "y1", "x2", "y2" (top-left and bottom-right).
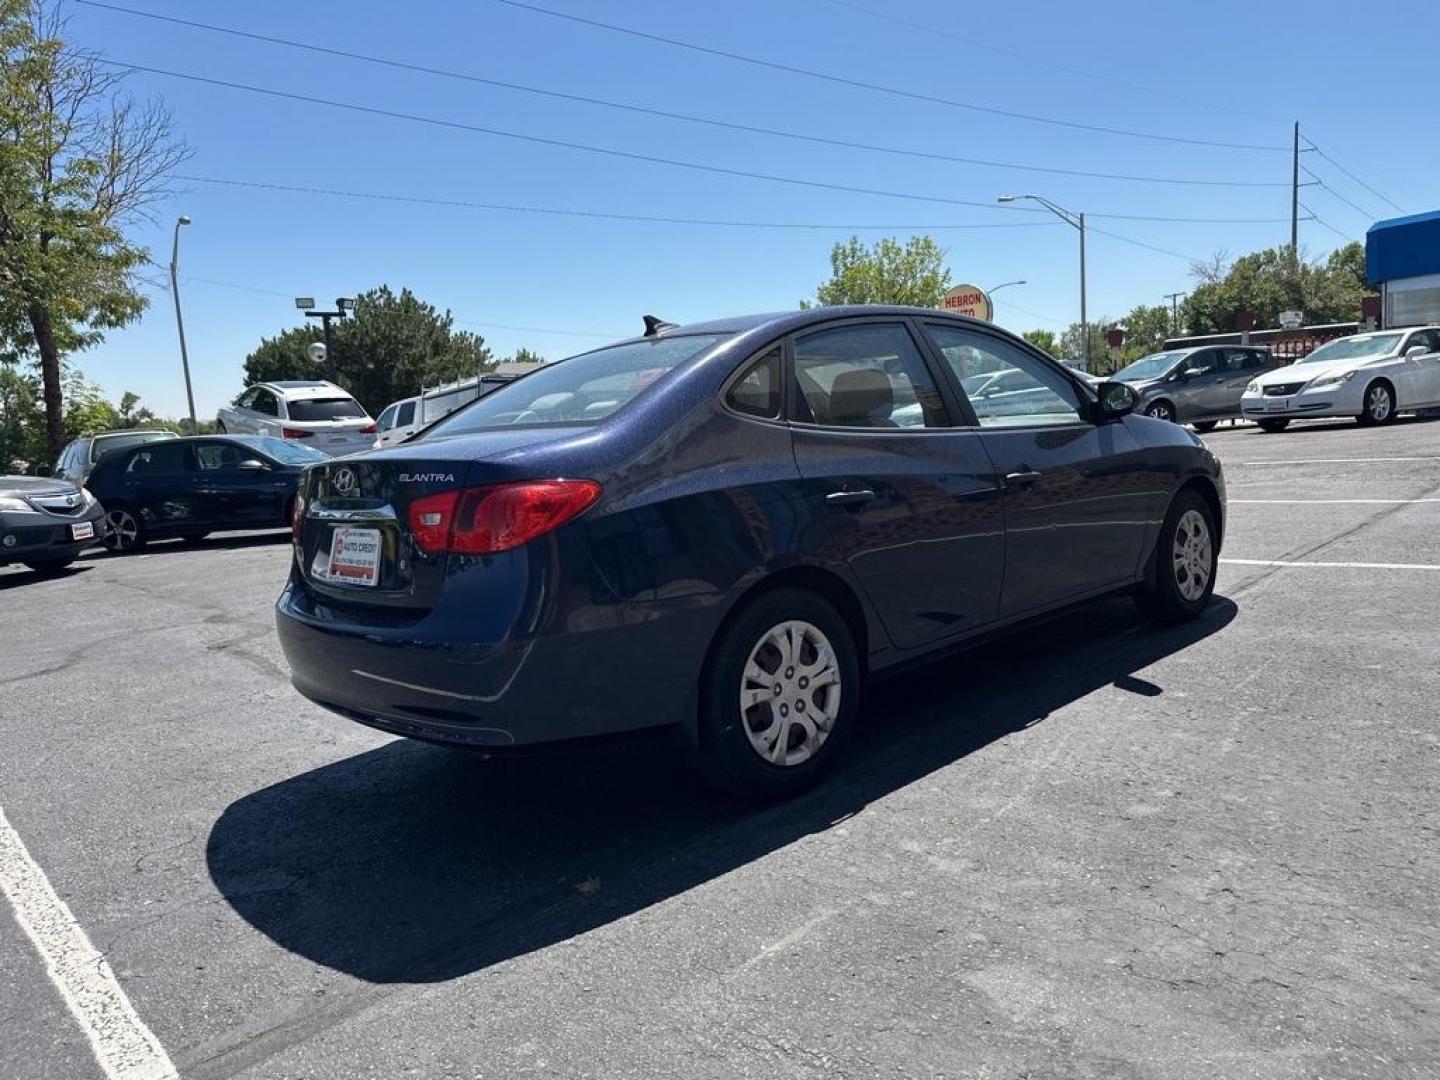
[{"x1": 1240, "y1": 327, "x2": 1440, "y2": 431}]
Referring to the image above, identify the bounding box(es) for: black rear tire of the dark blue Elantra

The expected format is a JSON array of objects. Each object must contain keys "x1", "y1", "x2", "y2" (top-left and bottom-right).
[{"x1": 698, "y1": 589, "x2": 860, "y2": 801}]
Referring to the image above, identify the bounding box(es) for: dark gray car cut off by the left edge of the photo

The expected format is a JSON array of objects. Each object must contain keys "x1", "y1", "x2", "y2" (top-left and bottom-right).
[{"x1": 0, "y1": 477, "x2": 105, "y2": 572}]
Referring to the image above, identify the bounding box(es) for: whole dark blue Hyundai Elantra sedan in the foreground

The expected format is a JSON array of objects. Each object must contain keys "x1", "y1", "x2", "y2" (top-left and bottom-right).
[{"x1": 278, "y1": 307, "x2": 1225, "y2": 798}]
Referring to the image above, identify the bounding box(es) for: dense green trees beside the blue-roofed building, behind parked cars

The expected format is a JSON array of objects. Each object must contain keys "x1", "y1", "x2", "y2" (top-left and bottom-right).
[{"x1": 1181, "y1": 242, "x2": 1368, "y2": 334}]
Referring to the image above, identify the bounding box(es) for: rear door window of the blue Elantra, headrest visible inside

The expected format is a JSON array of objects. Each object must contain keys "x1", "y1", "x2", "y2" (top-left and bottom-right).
[{"x1": 795, "y1": 323, "x2": 949, "y2": 429}]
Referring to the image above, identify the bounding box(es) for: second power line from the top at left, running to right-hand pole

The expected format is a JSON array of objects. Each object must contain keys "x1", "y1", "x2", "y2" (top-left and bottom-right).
[{"x1": 105, "y1": 60, "x2": 1280, "y2": 225}]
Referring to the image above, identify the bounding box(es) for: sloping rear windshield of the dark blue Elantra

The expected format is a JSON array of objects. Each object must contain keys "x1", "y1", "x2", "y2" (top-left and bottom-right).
[{"x1": 426, "y1": 334, "x2": 729, "y2": 436}]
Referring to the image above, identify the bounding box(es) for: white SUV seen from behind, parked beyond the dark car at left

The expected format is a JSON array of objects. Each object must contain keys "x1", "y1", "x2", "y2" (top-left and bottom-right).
[{"x1": 215, "y1": 380, "x2": 376, "y2": 456}]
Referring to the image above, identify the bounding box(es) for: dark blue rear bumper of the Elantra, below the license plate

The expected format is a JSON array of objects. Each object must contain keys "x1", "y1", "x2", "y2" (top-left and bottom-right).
[{"x1": 276, "y1": 580, "x2": 720, "y2": 750}]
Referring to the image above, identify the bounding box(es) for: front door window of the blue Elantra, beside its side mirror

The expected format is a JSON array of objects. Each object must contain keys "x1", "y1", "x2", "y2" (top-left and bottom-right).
[{"x1": 926, "y1": 324, "x2": 1081, "y2": 428}]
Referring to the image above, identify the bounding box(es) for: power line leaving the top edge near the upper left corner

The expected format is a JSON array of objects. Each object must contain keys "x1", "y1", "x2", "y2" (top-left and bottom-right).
[{"x1": 75, "y1": 0, "x2": 1284, "y2": 187}]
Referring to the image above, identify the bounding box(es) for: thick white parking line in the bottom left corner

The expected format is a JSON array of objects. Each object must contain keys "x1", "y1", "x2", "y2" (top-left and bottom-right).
[{"x1": 0, "y1": 809, "x2": 179, "y2": 1080}]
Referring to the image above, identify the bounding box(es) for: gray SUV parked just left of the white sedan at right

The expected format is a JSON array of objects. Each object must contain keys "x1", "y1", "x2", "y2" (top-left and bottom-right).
[{"x1": 1110, "y1": 346, "x2": 1280, "y2": 431}]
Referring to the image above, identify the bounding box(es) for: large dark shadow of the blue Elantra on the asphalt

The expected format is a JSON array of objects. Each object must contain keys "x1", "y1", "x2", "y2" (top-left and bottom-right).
[{"x1": 206, "y1": 596, "x2": 1237, "y2": 984}]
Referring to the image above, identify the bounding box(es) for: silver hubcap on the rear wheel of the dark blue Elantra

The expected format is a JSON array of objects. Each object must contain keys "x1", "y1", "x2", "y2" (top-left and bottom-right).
[{"x1": 740, "y1": 619, "x2": 840, "y2": 766}]
